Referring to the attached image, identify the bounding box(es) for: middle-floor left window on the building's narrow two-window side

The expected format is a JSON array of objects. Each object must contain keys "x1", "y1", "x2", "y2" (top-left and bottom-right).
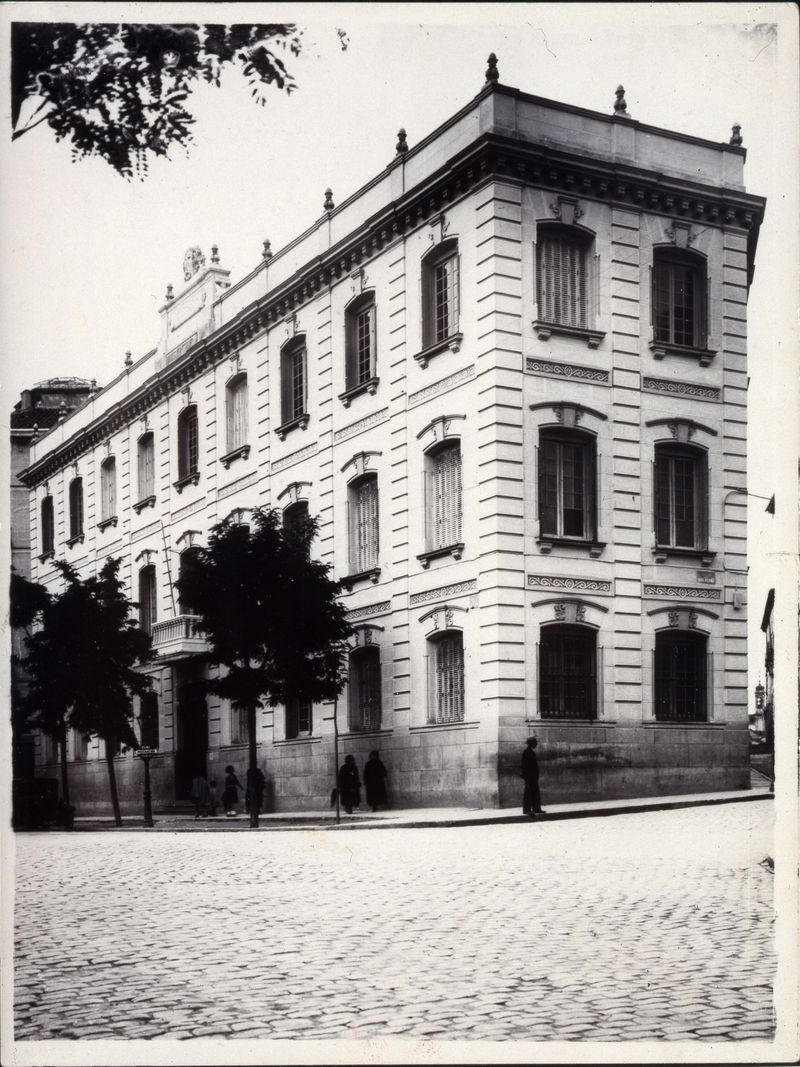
[{"x1": 538, "y1": 429, "x2": 597, "y2": 541}]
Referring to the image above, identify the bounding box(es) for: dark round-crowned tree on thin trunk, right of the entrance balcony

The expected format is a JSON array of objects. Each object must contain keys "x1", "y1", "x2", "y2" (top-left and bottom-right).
[{"x1": 176, "y1": 508, "x2": 352, "y2": 827}]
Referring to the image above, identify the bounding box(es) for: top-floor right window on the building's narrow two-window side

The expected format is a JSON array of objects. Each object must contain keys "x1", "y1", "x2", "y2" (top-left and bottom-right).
[{"x1": 652, "y1": 249, "x2": 708, "y2": 349}]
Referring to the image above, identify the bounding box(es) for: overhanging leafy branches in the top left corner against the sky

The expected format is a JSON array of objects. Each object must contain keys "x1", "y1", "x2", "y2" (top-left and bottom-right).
[{"x1": 12, "y1": 22, "x2": 309, "y2": 177}]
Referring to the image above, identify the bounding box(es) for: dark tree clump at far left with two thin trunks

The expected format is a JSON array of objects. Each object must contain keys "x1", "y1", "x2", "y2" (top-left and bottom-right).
[{"x1": 14, "y1": 558, "x2": 150, "y2": 826}]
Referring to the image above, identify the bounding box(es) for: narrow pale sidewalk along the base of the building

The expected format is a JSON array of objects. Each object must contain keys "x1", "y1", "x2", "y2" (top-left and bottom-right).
[{"x1": 68, "y1": 779, "x2": 773, "y2": 833}]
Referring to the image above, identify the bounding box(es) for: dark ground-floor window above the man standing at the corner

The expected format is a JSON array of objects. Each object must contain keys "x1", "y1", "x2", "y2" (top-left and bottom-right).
[{"x1": 539, "y1": 624, "x2": 597, "y2": 719}]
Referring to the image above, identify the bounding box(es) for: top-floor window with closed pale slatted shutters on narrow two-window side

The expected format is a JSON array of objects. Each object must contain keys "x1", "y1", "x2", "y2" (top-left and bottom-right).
[{"x1": 537, "y1": 223, "x2": 592, "y2": 330}]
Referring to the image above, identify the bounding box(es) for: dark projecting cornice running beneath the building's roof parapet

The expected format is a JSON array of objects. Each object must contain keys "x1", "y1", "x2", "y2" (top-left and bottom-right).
[{"x1": 19, "y1": 125, "x2": 765, "y2": 488}]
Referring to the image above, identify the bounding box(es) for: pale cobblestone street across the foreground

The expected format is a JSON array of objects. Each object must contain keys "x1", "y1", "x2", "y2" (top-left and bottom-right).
[{"x1": 15, "y1": 802, "x2": 774, "y2": 1041}]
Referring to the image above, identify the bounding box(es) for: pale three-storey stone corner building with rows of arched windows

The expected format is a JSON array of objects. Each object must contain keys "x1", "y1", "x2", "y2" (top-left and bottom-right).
[{"x1": 18, "y1": 66, "x2": 764, "y2": 810}]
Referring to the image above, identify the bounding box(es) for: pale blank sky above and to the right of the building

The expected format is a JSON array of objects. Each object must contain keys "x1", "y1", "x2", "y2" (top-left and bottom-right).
[{"x1": 0, "y1": 3, "x2": 800, "y2": 704}]
